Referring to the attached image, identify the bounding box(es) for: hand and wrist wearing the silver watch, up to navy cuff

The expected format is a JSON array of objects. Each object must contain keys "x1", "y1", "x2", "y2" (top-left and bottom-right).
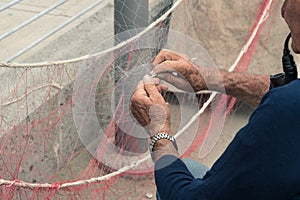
[{"x1": 130, "y1": 75, "x2": 178, "y2": 160}]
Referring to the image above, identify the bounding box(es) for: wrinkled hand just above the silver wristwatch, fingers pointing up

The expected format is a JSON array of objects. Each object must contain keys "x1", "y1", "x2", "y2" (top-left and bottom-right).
[{"x1": 130, "y1": 75, "x2": 170, "y2": 137}]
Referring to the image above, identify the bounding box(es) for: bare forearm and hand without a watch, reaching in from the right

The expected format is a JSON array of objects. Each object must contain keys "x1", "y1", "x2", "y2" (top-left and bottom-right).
[{"x1": 153, "y1": 50, "x2": 270, "y2": 107}]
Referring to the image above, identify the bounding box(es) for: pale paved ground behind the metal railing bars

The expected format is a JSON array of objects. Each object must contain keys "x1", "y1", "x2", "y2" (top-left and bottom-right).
[{"x1": 0, "y1": 0, "x2": 112, "y2": 62}]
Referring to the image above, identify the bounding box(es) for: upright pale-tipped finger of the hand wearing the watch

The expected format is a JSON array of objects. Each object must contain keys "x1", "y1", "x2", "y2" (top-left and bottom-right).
[{"x1": 143, "y1": 75, "x2": 165, "y2": 103}]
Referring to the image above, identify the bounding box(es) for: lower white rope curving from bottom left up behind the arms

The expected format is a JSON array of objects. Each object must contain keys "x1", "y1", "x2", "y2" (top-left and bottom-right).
[{"x1": 0, "y1": 0, "x2": 272, "y2": 189}]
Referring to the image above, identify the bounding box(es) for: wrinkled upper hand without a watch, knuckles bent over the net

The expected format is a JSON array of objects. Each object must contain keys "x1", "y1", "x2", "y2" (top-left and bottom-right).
[{"x1": 153, "y1": 49, "x2": 210, "y2": 92}]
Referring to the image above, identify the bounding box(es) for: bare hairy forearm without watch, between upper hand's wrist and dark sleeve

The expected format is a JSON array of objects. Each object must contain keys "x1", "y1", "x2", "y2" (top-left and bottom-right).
[{"x1": 208, "y1": 70, "x2": 270, "y2": 107}]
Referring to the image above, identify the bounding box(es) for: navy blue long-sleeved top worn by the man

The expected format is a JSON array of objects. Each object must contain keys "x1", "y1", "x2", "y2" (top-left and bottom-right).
[{"x1": 155, "y1": 80, "x2": 300, "y2": 200}]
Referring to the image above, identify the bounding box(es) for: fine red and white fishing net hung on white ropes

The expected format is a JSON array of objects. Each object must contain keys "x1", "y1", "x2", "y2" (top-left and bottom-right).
[{"x1": 0, "y1": 0, "x2": 296, "y2": 200}]
